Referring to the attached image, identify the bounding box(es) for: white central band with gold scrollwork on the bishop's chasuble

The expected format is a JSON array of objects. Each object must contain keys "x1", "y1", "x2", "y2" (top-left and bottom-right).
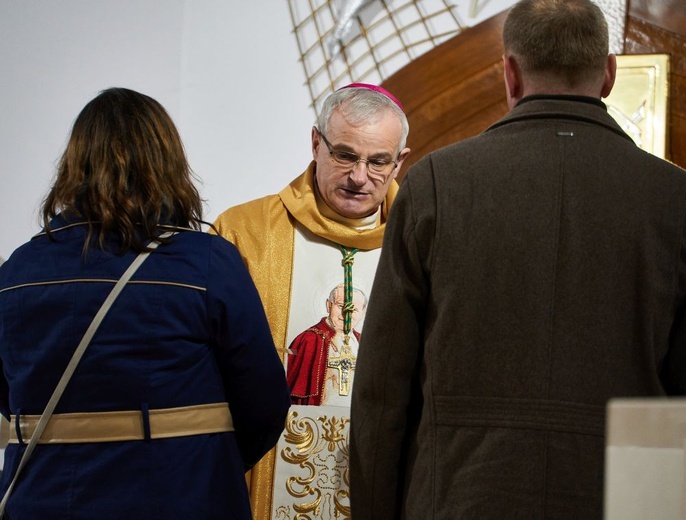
[{"x1": 272, "y1": 217, "x2": 381, "y2": 520}]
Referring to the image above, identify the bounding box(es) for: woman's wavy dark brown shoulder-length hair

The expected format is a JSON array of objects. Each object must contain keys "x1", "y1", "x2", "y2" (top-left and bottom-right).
[{"x1": 41, "y1": 88, "x2": 202, "y2": 252}]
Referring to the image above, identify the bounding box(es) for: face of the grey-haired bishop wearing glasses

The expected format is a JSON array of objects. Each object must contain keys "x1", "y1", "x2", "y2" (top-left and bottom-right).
[{"x1": 312, "y1": 109, "x2": 409, "y2": 219}]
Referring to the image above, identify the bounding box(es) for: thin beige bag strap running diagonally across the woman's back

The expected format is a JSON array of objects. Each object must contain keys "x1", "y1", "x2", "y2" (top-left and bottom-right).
[{"x1": 0, "y1": 231, "x2": 175, "y2": 518}]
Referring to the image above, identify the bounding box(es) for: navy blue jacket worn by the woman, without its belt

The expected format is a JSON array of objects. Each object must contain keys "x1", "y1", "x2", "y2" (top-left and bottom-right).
[{"x1": 0, "y1": 219, "x2": 290, "y2": 520}]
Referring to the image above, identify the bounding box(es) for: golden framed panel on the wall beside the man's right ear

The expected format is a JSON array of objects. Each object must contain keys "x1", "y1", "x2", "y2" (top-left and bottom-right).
[{"x1": 604, "y1": 54, "x2": 669, "y2": 159}]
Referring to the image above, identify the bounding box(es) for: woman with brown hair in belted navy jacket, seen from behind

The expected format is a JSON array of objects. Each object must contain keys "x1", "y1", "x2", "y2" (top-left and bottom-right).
[{"x1": 0, "y1": 88, "x2": 289, "y2": 520}]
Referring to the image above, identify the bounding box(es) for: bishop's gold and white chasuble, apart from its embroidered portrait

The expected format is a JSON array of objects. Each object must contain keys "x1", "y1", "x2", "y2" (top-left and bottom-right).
[{"x1": 215, "y1": 163, "x2": 398, "y2": 520}]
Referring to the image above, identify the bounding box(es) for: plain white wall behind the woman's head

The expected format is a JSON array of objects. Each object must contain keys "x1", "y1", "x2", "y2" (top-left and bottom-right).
[{"x1": 0, "y1": 0, "x2": 314, "y2": 258}]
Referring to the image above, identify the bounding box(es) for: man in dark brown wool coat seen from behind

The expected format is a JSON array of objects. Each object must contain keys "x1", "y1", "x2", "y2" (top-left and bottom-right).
[{"x1": 350, "y1": 0, "x2": 686, "y2": 520}]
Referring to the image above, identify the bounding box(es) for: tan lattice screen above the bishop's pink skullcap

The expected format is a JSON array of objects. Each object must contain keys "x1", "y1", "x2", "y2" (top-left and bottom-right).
[{"x1": 289, "y1": 0, "x2": 474, "y2": 116}]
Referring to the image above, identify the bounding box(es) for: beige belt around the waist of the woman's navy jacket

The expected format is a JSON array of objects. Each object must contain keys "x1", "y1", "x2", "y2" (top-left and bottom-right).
[{"x1": 9, "y1": 403, "x2": 234, "y2": 444}]
